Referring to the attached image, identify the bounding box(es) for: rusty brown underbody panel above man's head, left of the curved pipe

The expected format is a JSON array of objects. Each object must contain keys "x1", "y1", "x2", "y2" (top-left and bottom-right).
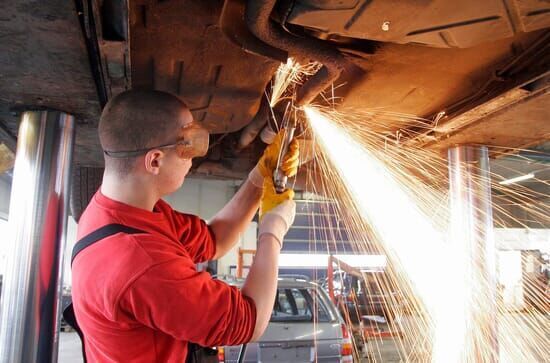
[{"x1": 130, "y1": 0, "x2": 279, "y2": 133}]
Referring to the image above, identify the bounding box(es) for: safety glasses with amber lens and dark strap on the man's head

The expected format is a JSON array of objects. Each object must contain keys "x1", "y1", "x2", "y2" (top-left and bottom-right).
[{"x1": 103, "y1": 122, "x2": 209, "y2": 159}]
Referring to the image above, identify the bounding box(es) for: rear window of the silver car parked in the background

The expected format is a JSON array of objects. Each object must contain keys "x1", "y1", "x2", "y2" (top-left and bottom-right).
[{"x1": 271, "y1": 288, "x2": 330, "y2": 322}]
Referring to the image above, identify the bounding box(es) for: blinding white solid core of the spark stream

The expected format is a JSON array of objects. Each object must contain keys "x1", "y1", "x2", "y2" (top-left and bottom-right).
[{"x1": 305, "y1": 108, "x2": 466, "y2": 362}]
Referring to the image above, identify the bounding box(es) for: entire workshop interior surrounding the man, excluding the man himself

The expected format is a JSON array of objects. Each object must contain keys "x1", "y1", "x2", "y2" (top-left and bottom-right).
[{"x1": 0, "y1": 0, "x2": 550, "y2": 363}]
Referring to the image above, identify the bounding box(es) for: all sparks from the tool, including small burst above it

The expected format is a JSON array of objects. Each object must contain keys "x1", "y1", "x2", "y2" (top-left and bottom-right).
[{"x1": 268, "y1": 59, "x2": 550, "y2": 362}]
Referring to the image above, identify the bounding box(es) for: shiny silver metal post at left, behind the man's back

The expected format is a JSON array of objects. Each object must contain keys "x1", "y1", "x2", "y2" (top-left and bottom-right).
[{"x1": 0, "y1": 111, "x2": 74, "y2": 363}]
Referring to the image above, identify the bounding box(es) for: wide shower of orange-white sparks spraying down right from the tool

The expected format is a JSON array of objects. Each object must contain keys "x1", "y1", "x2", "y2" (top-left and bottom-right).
[{"x1": 305, "y1": 107, "x2": 549, "y2": 362}]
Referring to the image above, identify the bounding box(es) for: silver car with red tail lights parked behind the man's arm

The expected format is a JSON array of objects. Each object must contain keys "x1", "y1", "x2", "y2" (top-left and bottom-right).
[{"x1": 218, "y1": 277, "x2": 353, "y2": 363}]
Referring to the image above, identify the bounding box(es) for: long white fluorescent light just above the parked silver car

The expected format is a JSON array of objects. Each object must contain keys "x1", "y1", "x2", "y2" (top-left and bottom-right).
[{"x1": 279, "y1": 253, "x2": 387, "y2": 270}]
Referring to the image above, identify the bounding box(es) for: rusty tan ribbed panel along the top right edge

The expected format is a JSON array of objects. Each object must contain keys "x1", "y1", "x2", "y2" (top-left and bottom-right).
[{"x1": 287, "y1": 0, "x2": 550, "y2": 48}]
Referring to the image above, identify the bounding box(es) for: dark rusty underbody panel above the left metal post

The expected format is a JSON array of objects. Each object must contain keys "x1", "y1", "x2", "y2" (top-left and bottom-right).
[{"x1": 0, "y1": 0, "x2": 103, "y2": 164}]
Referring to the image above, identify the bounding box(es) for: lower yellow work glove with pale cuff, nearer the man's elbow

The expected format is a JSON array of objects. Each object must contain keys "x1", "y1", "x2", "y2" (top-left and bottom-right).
[{"x1": 258, "y1": 178, "x2": 296, "y2": 248}]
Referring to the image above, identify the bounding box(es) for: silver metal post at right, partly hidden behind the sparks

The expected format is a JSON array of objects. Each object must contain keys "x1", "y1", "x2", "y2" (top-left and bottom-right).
[{"x1": 448, "y1": 146, "x2": 498, "y2": 362}]
